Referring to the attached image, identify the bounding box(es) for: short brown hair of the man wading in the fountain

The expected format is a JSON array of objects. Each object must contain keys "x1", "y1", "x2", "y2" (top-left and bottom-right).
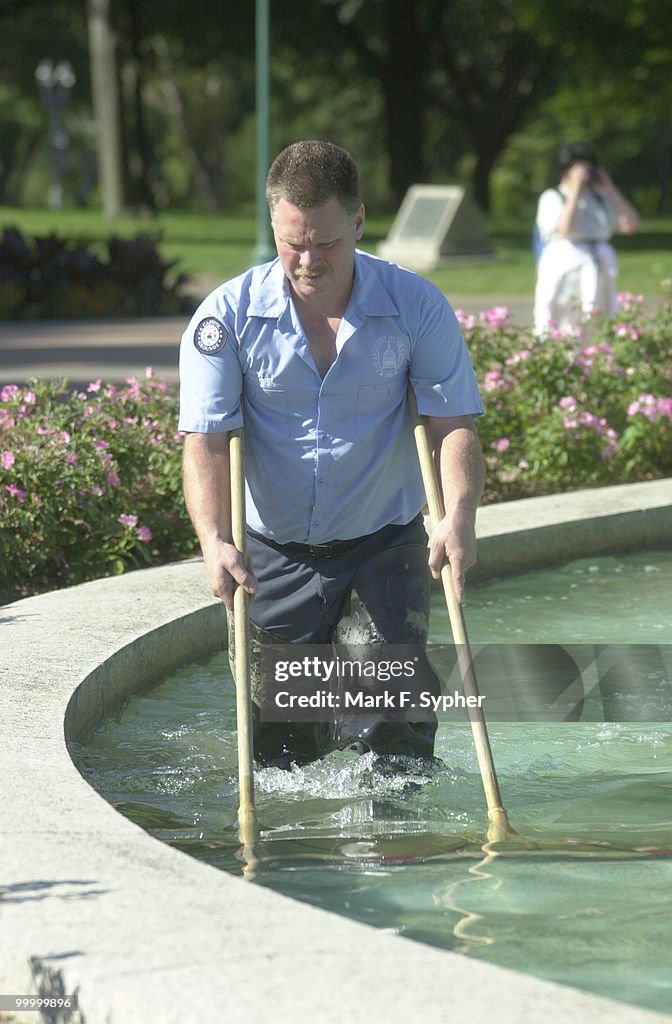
[{"x1": 266, "y1": 139, "x2": 362, "y2": 218}]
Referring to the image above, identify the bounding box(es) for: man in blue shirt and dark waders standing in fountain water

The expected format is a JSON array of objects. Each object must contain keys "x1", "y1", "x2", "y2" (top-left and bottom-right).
[{"x1": 179, "y1": 141, "x2": 482, "y2": 768}]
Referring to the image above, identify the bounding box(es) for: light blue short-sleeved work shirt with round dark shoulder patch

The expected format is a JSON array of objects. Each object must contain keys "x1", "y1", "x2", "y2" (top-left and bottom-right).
[{"x1": 179, "y1": 250, "x2": 482, "y2": 544}]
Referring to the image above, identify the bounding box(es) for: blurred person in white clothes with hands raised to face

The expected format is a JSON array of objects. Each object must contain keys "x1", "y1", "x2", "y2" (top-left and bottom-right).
[{"x1": 534, "y1": 142, "x2": 639, "y2": 337}]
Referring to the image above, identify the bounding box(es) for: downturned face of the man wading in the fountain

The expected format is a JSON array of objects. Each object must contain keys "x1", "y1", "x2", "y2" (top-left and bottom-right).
[{"x1": 272, "y1": 197, "x2": 364, "y2": 307}]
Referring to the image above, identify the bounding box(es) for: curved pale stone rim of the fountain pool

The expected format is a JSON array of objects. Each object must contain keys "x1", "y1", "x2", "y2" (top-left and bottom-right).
[{"x1": 0, "y1": 482, "x2": 672, "y2": 1024}]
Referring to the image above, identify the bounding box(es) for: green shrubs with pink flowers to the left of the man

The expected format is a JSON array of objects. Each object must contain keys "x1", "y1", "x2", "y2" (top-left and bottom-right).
[{"x1": 0, "y1": 371, "x2": 195, "y2": 596}]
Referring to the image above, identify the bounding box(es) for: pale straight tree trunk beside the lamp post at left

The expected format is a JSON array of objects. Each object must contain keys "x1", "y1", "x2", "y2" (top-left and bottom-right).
[{"x1": 87, "y1": 0, "x2": 124, "y2": 219}]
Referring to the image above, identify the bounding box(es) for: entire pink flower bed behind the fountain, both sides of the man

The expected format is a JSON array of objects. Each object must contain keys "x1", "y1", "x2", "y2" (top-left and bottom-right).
[{"x1": 0, "y1": 295, "x2": 672, "y2": 599}]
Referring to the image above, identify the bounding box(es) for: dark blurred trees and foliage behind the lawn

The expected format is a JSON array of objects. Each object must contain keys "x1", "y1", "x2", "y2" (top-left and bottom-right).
[{"x1": 0, "y1": 0, "x2": 672, "y2": 222}]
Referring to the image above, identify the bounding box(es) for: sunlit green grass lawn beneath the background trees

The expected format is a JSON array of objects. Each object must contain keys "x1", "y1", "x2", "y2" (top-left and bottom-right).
[{"x1": 0, "y1": 207, "x2": 672, "y2": 305}]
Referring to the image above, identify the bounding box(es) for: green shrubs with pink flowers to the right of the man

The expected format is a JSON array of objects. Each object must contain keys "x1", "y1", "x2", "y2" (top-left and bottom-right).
[{"x1": 465, "y1": 294, "x2": 672, "y2": 502}]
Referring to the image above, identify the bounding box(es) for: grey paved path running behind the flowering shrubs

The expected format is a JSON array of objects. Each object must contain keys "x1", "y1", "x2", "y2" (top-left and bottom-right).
[{"x1": 0, "y1": 296, "x2": 532, "y2": 387}]
